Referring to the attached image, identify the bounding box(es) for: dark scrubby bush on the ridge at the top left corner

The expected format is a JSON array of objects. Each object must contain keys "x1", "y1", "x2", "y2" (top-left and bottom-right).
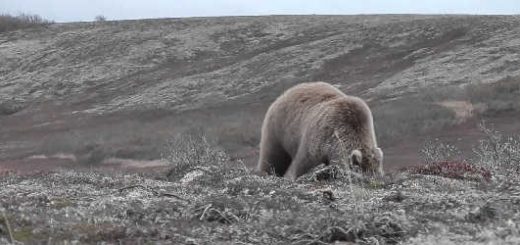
[{"x1": 0, "y1": 14, "x2": 54, "y2": 33}]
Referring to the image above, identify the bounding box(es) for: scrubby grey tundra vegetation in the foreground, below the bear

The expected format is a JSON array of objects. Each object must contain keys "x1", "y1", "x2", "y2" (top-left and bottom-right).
[{"x1": 0, "y1": 129, "x2": 520, "y2": 244}]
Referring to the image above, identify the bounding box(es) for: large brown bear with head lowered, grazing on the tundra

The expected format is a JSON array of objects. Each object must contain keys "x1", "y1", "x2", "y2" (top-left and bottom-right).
[{"x1": 257, "y1": 82, "x2": 383, "y2": 180}]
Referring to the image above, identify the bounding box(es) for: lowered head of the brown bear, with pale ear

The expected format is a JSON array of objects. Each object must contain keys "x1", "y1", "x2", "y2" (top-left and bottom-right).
[{"x1": 350, "y1": 147, "x2": 384, "y2": 177}]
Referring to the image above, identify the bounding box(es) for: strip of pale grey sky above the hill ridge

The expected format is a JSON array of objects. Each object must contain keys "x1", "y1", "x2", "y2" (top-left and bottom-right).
[{"x1": 0, "y1": 0, "x2": 520, "y2": 22}]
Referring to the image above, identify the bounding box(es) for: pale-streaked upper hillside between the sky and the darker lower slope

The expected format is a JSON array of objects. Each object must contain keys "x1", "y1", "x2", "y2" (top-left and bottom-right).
[{"x1": 0, "y1": 16, "x2": 520, "y2": 112}]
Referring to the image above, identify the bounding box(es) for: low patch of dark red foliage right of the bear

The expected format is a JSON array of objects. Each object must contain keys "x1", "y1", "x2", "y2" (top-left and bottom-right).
[{"x1": 410, "y1": 161, "x2": 491, "y2": 181}]
